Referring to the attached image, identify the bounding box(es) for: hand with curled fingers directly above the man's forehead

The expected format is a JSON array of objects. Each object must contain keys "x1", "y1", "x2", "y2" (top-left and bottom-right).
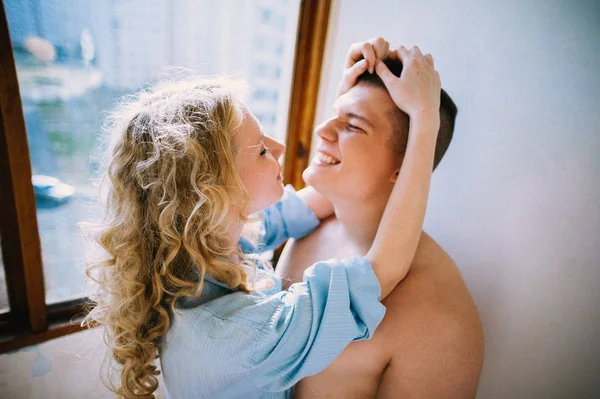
[{"x1": 337, "y1": 37, "x2": 397, "y2": 97}]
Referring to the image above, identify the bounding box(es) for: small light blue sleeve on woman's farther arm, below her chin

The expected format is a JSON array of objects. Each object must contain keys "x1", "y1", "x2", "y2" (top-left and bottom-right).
[{"x1": 258, "y1": 184, "x2": 320, "y2": 252}]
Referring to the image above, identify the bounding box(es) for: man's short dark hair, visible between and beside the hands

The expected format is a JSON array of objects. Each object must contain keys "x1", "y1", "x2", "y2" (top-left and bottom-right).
[{"x1": 356, "y1": 60, "x2": 458, "y2": 169}]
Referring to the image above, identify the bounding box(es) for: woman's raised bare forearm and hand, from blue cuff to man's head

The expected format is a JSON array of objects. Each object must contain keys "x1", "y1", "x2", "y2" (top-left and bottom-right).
[{"x1": 366, "y1": 46, "x2": 441, "y2": 299}]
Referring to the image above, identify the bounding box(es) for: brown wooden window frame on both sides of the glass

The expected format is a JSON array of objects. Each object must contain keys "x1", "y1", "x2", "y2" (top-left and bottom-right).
[{"x1": 0, "y1": 0, "x2": 331, "y2": 354}]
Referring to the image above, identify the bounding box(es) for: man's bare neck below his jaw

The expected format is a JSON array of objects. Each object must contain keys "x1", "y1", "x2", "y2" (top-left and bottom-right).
[{"x1": 332, "y1": 198, "x2": 386, "y2": 255}]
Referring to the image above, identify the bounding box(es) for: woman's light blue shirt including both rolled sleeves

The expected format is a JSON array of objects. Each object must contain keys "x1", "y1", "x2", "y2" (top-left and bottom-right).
[{"x1": 160, "y1": 186, "x2": 385, "y2": 399}]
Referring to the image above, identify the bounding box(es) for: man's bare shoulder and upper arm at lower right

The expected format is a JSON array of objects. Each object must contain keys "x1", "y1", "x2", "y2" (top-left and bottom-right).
[{"x1": 377, "y1": 235, "x2": 484, "y2": 398}]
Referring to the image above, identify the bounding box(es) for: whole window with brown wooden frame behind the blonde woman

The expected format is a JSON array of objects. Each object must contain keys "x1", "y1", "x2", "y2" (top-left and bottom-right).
[{"x1": 0, "y1": 0, "x2": 330, "y2": 353}]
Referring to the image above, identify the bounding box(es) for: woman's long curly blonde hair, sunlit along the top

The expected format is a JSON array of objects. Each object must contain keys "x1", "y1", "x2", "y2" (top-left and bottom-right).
[{"x1": 80, "y1": 78, "x2": 262, "y2": 398}]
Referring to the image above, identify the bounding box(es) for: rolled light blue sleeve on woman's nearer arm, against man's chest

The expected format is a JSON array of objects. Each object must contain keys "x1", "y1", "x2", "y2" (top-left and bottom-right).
[{"x1": 250, "y1": 257, "x2": 385, "y2": 391}]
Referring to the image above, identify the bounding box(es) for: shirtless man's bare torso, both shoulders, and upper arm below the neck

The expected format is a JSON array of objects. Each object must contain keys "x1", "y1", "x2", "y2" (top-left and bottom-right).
[{"x1": 276, "y1": 217, "x2": 483, "y2": 399}]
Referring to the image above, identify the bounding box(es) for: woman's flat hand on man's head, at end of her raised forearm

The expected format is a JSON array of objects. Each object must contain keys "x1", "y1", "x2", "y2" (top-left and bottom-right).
[{"x1": 375, "y1": 46, "x2": 441, "y2": 121}]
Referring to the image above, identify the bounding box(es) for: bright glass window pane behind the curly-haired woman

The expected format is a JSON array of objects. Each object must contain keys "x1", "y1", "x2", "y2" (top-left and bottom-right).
[{"x1": 4, "y1": 0, "x2": 299, "y2": 303}]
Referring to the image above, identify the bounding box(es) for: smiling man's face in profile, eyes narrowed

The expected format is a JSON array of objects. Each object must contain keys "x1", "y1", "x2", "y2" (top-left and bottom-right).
[{"x1": 302, "y1": 83, "x2": 406, "y2": 201}]
